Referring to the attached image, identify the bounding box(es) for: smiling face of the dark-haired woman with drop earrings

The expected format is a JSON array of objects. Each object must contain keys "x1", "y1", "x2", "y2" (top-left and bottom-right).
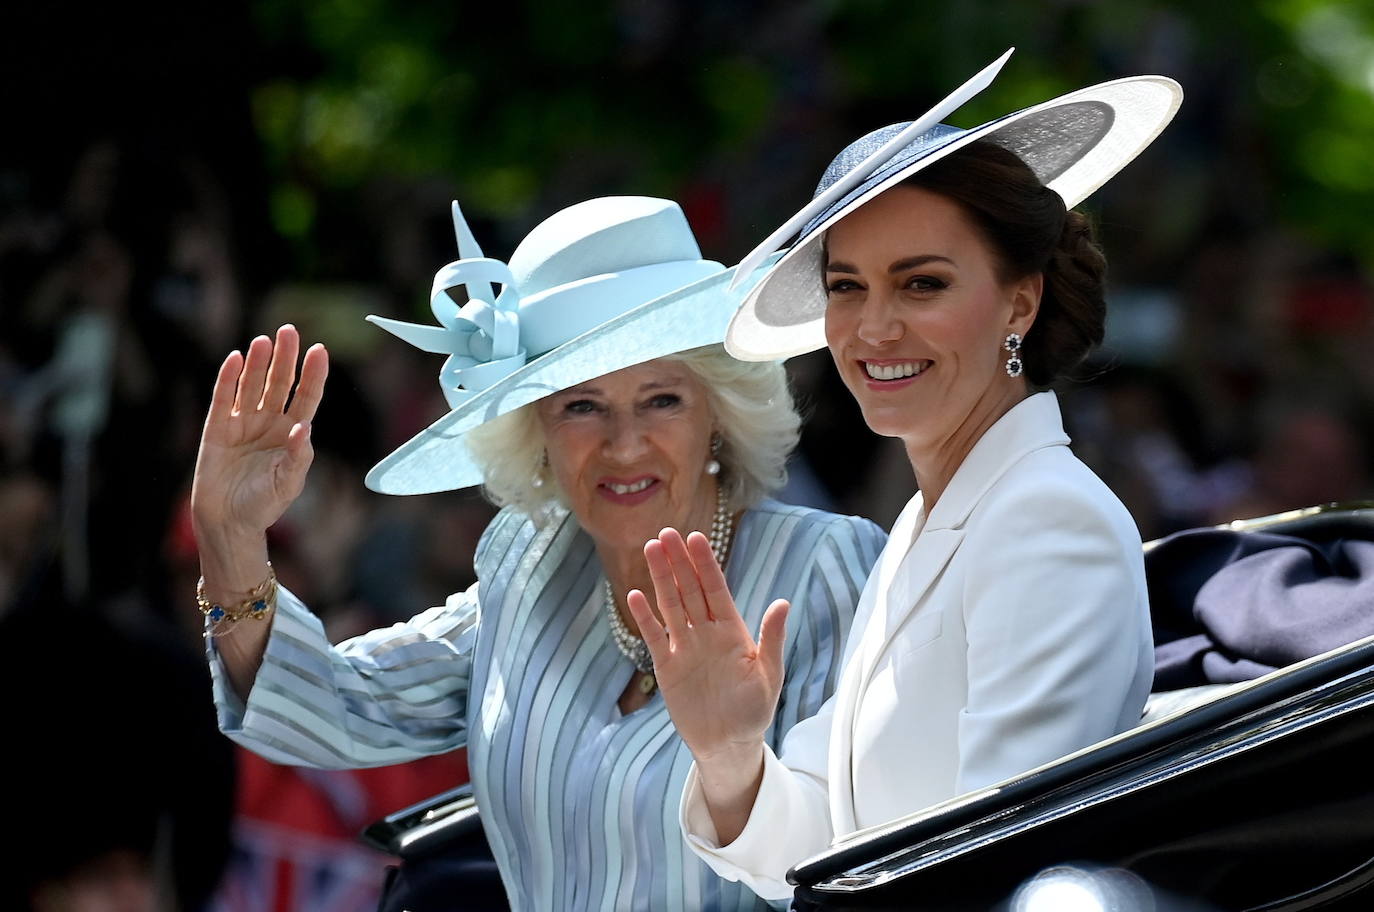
[{"x1": 824, "y1": 185, "x2": 1041, "y2": 456}]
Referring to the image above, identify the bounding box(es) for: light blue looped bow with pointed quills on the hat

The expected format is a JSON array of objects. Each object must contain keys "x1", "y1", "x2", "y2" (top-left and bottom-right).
[{"x1": 367, "y1": 202, "x2": 526, "y2": 408}]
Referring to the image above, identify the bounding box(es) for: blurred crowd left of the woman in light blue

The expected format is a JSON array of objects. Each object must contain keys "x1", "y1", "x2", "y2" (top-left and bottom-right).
[{"x1": 0, "y1": 141, "x2": 492, "y2": 912}]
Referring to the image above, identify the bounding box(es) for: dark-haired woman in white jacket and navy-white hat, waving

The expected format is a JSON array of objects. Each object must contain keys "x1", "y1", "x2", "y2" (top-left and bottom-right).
[{"x1": 631, "y1": 60, "x2": 1180, "y2": 897}]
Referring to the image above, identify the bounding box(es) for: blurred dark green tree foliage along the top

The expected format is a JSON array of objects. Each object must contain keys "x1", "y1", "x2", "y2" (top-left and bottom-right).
[{"x1": 251, "y1": 0, "x2": 1374, "y2": 274}]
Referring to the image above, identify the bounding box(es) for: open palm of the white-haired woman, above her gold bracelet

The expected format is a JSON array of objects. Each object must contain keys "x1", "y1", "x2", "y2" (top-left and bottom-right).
[{"x1": 191, "y1": 326, "x2": 328, "y2": 536}]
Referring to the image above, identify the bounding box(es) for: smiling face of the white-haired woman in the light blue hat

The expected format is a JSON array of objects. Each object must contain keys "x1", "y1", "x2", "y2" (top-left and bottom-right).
[{"x1": 537, "y1": 360, "x2": 716, "y2": 560}]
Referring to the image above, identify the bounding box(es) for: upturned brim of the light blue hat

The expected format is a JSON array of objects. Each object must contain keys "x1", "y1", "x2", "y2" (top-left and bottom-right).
[{"x1": 364, "y1": 255, "x2": 778, "y2": 494}]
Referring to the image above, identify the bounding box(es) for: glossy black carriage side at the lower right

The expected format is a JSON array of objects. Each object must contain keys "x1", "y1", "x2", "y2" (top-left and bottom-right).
[{"x1": 789, "y1": 510, "x2": 1374, "y2": 912}]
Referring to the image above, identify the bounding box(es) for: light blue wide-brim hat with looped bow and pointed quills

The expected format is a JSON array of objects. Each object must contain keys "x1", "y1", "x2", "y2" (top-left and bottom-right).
[{"x1": 365, "y1": 196, "x2": 761, "y2": 494}]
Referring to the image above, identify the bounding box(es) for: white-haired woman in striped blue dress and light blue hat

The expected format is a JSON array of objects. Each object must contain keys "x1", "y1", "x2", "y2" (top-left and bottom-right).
[{"x1": 192, "y1": 198, "x2": 883, "y2": 909}]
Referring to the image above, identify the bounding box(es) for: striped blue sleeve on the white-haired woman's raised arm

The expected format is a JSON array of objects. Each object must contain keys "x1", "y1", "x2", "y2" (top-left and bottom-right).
[{"x1": 207, "y1": 582, "x2": 480, "y2": 769}]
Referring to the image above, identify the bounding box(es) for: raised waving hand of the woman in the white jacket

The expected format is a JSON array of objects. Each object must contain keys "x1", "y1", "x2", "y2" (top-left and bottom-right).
[{"x1": 628, "y1": 529, "x2": 789, "y2": 845}]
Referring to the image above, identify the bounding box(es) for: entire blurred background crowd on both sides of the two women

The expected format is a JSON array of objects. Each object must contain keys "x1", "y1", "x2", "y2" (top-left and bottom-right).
[{"x1": 0, "y1": 4, "x2": 1374, "y2": 912}]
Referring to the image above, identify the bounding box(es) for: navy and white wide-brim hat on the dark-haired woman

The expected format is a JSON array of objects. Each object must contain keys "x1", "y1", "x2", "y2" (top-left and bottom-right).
[{"x1": 725, "y1": 51, "x2": 1183, "y2": 361}]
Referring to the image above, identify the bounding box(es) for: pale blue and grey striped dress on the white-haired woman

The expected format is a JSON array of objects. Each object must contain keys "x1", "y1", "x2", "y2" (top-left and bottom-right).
[{"x1": 209, "y1": 500, "x2": 886, "y2": 912}]
